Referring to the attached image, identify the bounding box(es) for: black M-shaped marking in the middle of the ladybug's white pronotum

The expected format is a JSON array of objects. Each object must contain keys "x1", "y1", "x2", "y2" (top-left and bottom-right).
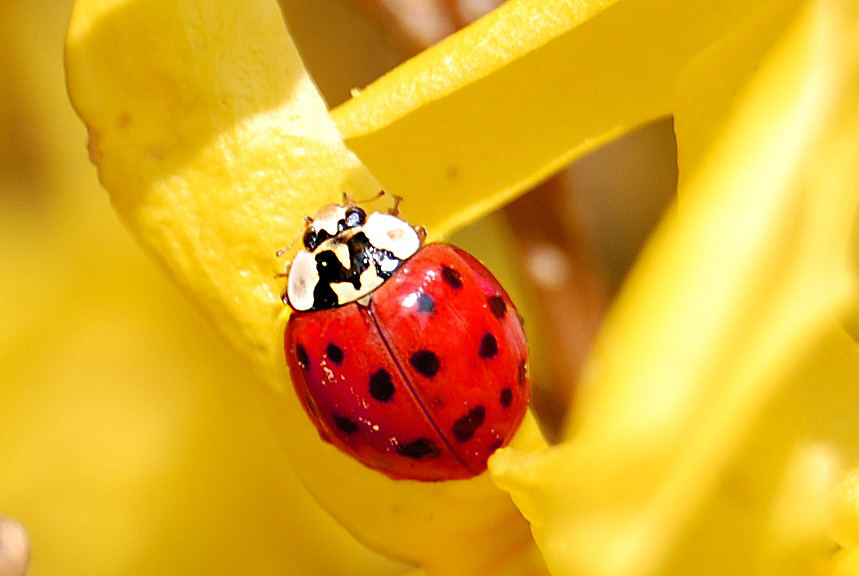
[{"x1": 311, "y1": 232, "x2": 403, "y2": 310}]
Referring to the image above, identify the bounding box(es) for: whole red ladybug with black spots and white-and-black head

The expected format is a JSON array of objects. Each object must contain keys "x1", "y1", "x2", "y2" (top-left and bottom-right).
[{"x1": 283, "y1": 196, "x2": 530, "y2": 481}]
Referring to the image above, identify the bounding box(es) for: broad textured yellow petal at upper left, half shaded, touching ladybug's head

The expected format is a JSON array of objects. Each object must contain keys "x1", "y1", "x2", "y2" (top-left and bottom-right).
[{"x1": 66, "y1": 0, "x2": 378, "y2": 376}]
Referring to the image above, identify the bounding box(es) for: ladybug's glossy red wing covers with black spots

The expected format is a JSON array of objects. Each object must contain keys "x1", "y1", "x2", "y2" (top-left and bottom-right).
[{"x1": 284, "y1": 244, "x2": 530, "y2": 481}]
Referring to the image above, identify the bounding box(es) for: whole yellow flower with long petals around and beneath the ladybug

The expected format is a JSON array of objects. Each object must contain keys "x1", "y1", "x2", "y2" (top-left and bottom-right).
[{"x1": 58, "y1": 0, "x2": 859, "y2": 575}]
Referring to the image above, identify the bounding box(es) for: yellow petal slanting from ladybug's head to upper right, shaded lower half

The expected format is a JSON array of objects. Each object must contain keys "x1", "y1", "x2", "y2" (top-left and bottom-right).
[{"x1": 332, "y1": 0, "x2": 748, "y2": 236}]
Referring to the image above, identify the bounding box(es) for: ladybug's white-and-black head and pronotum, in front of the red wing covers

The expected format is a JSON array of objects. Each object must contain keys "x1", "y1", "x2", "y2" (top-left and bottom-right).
[{"x1": 285, "y1": 202, "x2": 423, "y2": 311}]
